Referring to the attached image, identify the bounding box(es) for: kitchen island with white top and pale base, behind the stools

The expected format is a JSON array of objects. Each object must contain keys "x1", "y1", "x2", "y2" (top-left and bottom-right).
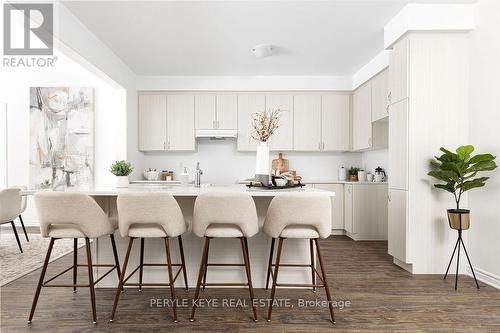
[{"x1": 22, "y1": 184, "x2": 335, "y2": 288}]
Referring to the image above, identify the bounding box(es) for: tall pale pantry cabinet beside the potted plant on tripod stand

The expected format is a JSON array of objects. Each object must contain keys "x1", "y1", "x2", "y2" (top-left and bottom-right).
[{"x1": 387, "y1": 33, "x2": 469, "y2": 274}]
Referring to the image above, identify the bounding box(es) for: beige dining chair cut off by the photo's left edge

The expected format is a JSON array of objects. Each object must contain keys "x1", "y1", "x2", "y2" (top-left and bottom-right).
[{"x1": 0, "y1": 188, "x2": 24, "y2": 253}]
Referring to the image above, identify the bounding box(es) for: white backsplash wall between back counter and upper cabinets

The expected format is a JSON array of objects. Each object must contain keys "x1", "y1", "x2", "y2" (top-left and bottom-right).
[{"x1": 143, "y1": 138, "x2": 361, "y2": 184}]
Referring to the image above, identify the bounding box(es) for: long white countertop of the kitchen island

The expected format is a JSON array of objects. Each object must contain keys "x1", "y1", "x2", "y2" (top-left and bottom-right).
[{"x1": 21, "y1": 184, "x2": 335, "y2": 197}]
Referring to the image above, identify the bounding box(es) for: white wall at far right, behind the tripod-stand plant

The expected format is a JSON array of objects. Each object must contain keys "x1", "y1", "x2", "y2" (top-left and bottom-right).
[{"x1": 468, "y1": 0, "x2": 500, "y2": 288}]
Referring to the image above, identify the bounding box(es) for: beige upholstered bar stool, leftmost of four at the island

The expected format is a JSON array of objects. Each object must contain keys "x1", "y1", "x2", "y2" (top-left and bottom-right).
[{"x1": 28, "y1": 192, "x2": 120, "y2": 324}]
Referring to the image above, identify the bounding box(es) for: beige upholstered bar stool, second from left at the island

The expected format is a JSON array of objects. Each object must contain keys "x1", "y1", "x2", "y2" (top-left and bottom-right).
[{"x1": 110, "y1": 193, "x2": 188, "y2": 322}]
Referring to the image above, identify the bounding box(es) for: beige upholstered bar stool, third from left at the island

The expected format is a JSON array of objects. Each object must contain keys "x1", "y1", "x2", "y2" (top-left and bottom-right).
[{"x1": 190, "y1": 193, "x2": 259, "y2": 321}]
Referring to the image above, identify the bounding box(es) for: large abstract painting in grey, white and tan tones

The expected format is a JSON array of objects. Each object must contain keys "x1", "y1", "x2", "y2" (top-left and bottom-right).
[{"x1": 30, "y1": 87, "x2": 94, "y2": 189}]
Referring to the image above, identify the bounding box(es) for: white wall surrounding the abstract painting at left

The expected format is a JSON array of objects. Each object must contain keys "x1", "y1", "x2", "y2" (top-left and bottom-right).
[{"x1": 0, "y1": 51, "x2": 126, "y2": 224}]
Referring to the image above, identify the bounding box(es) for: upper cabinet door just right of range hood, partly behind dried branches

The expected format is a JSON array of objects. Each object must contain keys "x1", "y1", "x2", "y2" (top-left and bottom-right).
[{"x1": 238, "y1": 94, "x2": 266, "y2": 151}]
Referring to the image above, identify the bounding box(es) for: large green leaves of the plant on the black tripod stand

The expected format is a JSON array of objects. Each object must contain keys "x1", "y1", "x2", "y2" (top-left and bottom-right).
[{"x1": 427, "y1": 145, "x2": 497, "y2": 209}]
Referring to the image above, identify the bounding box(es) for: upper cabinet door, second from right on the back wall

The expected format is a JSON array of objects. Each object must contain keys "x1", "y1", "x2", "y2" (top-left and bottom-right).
[{"x1": 293, "y1": 95, "x2": 321, "y2": 151}]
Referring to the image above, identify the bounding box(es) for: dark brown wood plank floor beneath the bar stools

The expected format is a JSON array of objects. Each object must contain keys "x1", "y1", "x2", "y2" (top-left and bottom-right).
[{"x1": 0, "y1": 236, "x2": 500, "y2": 333}]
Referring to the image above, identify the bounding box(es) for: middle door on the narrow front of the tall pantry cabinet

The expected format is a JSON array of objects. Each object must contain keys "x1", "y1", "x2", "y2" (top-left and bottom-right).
[{"x1": 389, "y1": 99, "x2": 408, "y2": 190}]
